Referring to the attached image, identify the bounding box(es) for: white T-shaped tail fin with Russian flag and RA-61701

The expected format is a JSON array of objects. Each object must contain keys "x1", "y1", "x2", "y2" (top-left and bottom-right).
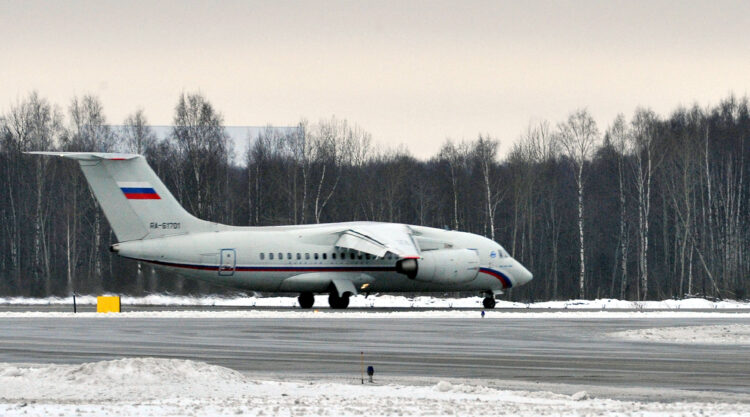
[{"x1": 28, "y1": 152, "x2": 213, "y2": 242}]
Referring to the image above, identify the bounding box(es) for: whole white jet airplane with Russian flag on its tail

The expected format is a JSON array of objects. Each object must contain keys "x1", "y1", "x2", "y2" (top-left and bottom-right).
[{"x1": 28, "y1": 152, "x2": 533, "y2": 309}]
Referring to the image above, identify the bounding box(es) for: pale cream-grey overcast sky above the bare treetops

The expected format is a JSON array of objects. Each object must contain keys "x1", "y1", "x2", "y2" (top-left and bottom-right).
[{"x1": 0, "y1": 0, "x2": 750, "y2": 158}]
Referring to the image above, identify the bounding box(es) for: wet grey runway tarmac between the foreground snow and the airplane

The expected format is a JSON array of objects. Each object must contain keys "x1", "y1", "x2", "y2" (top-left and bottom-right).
[{"x1": 0, "y1": 314, "x2": 750, "y2": 398}]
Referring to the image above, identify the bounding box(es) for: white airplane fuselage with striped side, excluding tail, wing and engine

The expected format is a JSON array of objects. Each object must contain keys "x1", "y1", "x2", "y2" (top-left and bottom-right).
[{"x1": 113, "y1": 222, "x2": 531, "y2": 292}]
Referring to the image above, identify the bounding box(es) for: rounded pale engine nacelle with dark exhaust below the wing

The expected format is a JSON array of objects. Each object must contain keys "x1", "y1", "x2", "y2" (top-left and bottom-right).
[{"x1": 396, "y1": 249, "x2": 479, "y2": 284}]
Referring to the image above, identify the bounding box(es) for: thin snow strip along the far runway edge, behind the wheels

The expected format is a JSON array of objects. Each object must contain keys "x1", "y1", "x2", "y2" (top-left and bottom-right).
[{"x1": 0, "y1": 294, "x2": 750, "y2": 311}]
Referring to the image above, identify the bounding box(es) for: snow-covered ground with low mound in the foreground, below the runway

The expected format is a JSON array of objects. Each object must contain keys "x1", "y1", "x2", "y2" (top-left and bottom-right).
[{"x1": 0, "y1": 358, "x2": 750, "y2": 417}]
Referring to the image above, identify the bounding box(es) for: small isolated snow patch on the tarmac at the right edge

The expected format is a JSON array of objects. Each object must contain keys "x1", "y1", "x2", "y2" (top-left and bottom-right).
[{"x1": 611, "y1": 324, "x2": 750, "y2": 345}]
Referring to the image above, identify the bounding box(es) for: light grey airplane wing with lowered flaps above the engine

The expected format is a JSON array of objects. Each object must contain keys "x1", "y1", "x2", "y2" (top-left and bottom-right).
[{"x1": 335, "y1": 223, "x2": 419, "y2": 258}]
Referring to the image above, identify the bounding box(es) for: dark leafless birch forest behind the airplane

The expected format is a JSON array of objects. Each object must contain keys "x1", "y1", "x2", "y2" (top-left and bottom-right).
[{"x1": 0, "y1": 93, "x2": 750, "y2": 300}]
